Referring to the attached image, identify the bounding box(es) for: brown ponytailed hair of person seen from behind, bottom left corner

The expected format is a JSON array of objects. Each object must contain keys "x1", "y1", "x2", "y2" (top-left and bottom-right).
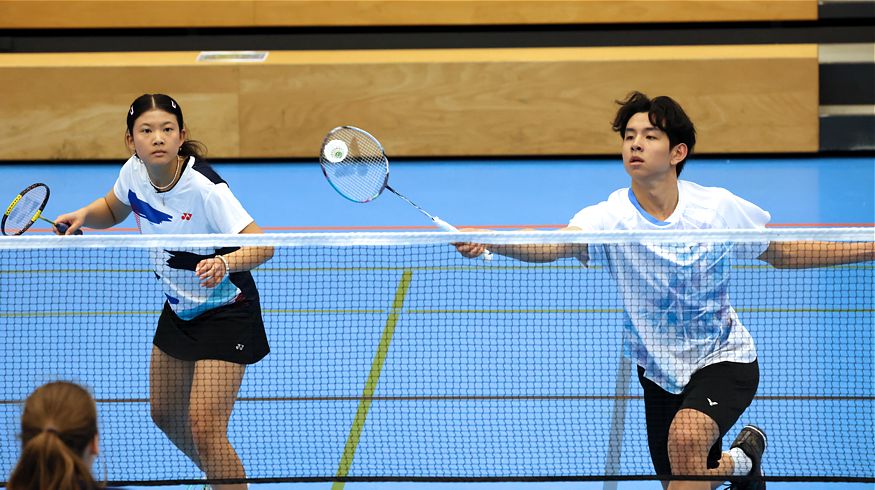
[{"x1": 7, "y1": 381, "x2": 98, "y2": 490}]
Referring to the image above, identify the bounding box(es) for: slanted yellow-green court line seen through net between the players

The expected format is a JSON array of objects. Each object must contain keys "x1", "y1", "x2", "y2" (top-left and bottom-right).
[{"x1": 331, "y1": 270, "x2": 413, "y2": 490}]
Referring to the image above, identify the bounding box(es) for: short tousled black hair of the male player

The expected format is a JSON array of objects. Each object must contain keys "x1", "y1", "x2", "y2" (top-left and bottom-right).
[{"x1": 612, "y1": 92, "x2": 696, "y2": 175}]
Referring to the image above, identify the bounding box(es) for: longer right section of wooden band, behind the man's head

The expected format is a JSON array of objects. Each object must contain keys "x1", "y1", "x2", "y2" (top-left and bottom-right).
[{"x1": 240, "y1": 46, "x2": 818, "y2": 156}]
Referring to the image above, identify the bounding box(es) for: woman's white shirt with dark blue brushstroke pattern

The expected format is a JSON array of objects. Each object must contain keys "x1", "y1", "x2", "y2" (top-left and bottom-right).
[{"x1": 113, "y1": 157, "x2": 258, "y2": 320}]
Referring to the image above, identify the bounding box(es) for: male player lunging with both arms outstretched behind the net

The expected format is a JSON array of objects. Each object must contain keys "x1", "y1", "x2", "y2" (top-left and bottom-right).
[{"x1": 457, "y1": 92, "x2": 875, "y2": 490}]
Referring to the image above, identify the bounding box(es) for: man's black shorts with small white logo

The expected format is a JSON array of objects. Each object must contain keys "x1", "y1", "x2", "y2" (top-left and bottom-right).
[{"x1": 638, "y1": 361, "x2": 760, "y2": 475}]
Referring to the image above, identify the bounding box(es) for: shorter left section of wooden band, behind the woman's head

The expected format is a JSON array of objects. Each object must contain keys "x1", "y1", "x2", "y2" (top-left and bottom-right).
[{"x1": 0, "y1": 53, "x2": 240, "y2": 160}]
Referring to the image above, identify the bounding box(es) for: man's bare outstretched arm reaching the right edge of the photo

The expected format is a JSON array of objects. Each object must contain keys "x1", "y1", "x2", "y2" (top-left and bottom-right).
[{"x1": 760, "y1": 241, "x2": 875, "y2": 269}]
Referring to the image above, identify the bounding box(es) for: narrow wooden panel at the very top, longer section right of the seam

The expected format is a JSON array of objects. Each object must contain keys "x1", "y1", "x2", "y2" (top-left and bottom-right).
[{"x1": 255, "y1": 0, "x2": 817, "y2": 26}]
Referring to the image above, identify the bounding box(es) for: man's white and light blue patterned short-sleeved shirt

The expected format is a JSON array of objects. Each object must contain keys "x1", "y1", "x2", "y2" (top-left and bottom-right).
[{"x1": 569, "y1": 180, "x2": 771, "y2": 394}]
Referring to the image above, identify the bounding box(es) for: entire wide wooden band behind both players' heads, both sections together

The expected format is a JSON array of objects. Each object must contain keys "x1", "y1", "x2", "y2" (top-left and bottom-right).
[{"x1": 0, "y1": 45, "x2": 818, "y2": 160}]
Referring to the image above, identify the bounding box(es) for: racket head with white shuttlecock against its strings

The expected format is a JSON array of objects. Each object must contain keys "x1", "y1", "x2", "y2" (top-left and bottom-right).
[{"x1": 319, "y1": 126, "x2": 389, "y2": 202}]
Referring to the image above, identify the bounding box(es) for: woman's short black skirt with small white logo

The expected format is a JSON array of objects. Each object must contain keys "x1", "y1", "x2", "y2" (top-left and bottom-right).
[{"x1": 152, "y1": 300, "x2": 270, "y2": 364}]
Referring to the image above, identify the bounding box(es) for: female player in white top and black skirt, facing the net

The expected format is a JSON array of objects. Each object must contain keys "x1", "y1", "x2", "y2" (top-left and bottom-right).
[{"x1": 55, "y1": 94, "x2": 273, "y2": 489}]
